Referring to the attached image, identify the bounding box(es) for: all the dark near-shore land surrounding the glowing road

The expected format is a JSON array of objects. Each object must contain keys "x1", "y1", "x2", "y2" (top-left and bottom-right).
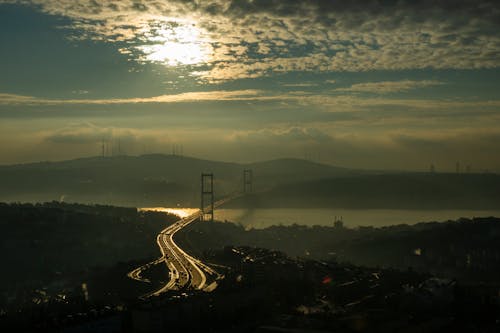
[{"x1": 0, "y1": 203, "x2": 500, "y2": 332}]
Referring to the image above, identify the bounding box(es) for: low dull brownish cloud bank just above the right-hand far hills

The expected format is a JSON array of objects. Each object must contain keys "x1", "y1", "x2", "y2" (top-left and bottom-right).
[{"x1": 221, "y1": 124, "x2": 500, "y2": 172}]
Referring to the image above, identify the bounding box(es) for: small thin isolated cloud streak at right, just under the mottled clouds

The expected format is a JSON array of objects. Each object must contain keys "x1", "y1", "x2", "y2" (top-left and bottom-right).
[{"x1": 335, "y1": 80, "x2": 444, "y2": 94}]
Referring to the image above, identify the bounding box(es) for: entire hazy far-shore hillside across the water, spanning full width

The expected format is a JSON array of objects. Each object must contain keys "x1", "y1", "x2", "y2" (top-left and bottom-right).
[{"x1": 0, "y1": 154, "x2": 500, "y2": 209}]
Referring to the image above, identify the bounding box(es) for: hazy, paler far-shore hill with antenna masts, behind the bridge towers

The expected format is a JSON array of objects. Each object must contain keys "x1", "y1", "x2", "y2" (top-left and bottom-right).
[{"x1": 0, "y1": 154, "x2": 357, "y2": 206}]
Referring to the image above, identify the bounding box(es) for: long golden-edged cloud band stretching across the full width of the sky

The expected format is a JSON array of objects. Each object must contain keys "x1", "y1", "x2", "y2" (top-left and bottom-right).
[{"x1": 0, "y1": 89, "x2": 500, "y2": 120}]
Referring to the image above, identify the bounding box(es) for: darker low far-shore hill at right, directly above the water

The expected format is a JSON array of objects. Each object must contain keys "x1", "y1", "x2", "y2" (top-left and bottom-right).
[{"x1": 233, "y1": 173, "x2": 500, "y2": 209}]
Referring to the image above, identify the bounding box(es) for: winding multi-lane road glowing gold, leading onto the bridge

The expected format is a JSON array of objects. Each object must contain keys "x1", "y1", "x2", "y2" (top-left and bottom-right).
[{"x1": 127, "y1": 194, "x2": 239, "y2": 298}]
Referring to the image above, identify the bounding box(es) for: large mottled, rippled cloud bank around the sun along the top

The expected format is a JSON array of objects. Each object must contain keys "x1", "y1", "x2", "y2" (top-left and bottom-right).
[{"x1": 9, "y1": 0, "x2": 500, "y2": 83}]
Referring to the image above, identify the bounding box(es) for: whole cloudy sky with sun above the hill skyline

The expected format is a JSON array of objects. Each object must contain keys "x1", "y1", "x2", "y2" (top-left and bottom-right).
[{"x1": 0, "y1": 0, "x2": 500, "y2": 172}]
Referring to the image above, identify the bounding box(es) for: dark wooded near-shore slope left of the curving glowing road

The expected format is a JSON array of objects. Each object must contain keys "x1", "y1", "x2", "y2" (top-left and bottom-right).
[{"x1": 0, "y1": 202, "x2": 177, "y2": 290}]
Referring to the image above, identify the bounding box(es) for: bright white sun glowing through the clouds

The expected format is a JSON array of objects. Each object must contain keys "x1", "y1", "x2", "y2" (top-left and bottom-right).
[{"x1": 138, "y1": 24, "x2": 213, "y2": 66}]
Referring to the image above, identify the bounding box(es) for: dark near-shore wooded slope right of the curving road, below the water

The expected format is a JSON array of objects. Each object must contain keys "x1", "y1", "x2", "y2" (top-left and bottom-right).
[{"x1": 176, "y1": 217, "x2": 500, "y2": 283}]
